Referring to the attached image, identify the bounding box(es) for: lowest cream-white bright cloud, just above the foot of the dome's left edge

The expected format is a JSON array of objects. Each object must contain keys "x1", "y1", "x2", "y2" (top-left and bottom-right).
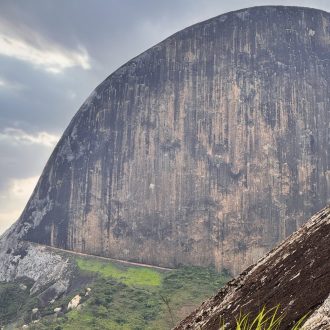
[{"x1": 0, "y1": 176, "x2": 39, "y2": 235}]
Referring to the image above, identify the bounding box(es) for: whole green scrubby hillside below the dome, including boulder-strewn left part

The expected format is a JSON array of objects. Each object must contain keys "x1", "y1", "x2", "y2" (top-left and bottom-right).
[{"x1": 0, "y1": 251, "x2": 229, "y2": 330}]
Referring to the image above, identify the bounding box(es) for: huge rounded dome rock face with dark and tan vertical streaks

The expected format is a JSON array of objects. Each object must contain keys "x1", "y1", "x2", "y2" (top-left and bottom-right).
[{"x1": 1, "y1": 7, "x2": 330, "y2": 274}]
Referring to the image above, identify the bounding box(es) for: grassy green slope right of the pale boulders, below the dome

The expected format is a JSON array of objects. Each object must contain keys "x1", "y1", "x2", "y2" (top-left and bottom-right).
[{"x1": 0, "y1": 257, "x2": 229, "y2": 330}]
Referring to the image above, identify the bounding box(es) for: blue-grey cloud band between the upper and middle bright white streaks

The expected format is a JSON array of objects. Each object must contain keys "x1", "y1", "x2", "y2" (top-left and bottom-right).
[{"x1": 0, "y1": 57, "x2": 96, "y2": 133}]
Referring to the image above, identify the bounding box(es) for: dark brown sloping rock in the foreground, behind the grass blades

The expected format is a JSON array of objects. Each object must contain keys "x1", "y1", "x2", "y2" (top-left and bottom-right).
[{"x1": 175, "y1": 206, "x2": 330, "y2": 330}]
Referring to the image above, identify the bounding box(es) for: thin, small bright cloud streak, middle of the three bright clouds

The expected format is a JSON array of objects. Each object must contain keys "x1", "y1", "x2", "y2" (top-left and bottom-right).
[{"x1": 0, "y1": 128, "x2": 59, "y2": 147}]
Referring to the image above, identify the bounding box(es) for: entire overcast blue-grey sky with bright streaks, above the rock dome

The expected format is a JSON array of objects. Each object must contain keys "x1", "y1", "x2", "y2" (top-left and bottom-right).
[{"x1": 0, "y1": 0, "x2": 330, "y2": 234}]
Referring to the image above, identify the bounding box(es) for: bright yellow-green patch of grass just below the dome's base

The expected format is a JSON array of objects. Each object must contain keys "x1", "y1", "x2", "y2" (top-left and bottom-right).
[{"x1": 77, "y1": 258, "x2": 162, "y2": 286}]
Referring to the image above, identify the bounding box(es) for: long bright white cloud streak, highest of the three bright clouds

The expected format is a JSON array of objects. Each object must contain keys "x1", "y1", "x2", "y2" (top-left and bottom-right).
[{"x1": 0, "y1": 32, "x2": 91, "y2": 73}]
